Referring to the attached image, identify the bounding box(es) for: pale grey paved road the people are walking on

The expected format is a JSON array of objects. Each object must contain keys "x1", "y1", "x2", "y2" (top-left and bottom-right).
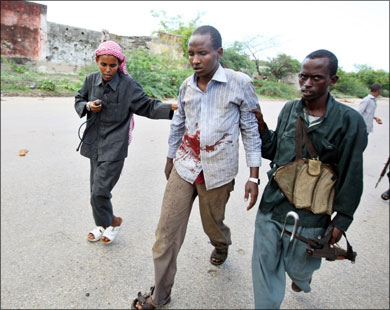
[{"x1": 1, "y1": 97, "x2": 389, "y2": 309}]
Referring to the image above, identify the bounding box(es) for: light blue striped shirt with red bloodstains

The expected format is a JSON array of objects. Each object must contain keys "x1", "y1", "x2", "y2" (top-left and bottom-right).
[{"x1": 168, "y1": 65, "x2": 261, "y2": 190}]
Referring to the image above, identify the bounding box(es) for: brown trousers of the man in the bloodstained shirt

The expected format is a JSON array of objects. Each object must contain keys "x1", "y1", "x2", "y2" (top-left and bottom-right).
[{"x1": 152, "y1": 168, "x2": 234, "y2": 307}]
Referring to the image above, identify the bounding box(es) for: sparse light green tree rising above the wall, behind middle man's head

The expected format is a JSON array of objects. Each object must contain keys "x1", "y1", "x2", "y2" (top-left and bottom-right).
[{"x1": 151, "y1": 10, "x2": 204, "y2": 58}]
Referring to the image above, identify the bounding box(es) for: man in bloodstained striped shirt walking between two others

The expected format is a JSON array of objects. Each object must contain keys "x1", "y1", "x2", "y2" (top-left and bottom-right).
[{"x1": 133, "y1": 26, "x2": 261, "y2": 309}]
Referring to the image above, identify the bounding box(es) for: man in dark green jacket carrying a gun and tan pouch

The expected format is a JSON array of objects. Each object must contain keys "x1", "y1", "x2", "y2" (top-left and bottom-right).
[{"x1": 252, "y1": 50, "x2": 367, "y2": 309}]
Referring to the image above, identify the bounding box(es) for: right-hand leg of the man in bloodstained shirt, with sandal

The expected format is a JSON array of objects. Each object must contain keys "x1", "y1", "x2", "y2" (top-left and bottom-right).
[{"x1": 195, "y1": 180, "x2": 234, "y2": 265}]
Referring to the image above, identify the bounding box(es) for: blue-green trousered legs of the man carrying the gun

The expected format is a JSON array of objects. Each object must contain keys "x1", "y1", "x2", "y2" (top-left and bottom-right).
[{"x1": 252, "y1": 210, "x2": 325, "y2": 309}]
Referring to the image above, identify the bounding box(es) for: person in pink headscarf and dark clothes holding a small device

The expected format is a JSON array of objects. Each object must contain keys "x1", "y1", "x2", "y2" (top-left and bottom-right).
[{"x1": 75, "y1": 41, "x2": 177, "y2": 244}]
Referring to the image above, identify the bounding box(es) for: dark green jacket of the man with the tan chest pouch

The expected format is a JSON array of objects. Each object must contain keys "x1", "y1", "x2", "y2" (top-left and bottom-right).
[{"x1": 260, "y1": 94, "x2": 367, "y2": 231}]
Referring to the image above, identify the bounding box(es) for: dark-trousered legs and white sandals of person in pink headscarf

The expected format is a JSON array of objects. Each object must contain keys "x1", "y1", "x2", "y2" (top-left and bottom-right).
[{"x1": 88, "y1": 159, "x2": 125, "y2": 243}]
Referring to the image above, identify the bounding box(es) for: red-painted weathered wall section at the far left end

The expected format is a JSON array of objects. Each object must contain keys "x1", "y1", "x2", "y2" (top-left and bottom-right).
[{"x1": 1, "y1": 1, "x2": 47, "y2": 60}]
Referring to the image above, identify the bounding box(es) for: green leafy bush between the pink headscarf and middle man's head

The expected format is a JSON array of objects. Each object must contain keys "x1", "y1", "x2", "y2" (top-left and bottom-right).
[{"x1": 126, "y1": 47, "x2": 193, "y2": 99}]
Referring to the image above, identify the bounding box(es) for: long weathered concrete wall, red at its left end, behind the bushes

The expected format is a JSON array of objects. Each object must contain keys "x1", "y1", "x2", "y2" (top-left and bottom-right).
[{"x1": 1, "y1": 1, "x2": 182, "y2": 73}]
